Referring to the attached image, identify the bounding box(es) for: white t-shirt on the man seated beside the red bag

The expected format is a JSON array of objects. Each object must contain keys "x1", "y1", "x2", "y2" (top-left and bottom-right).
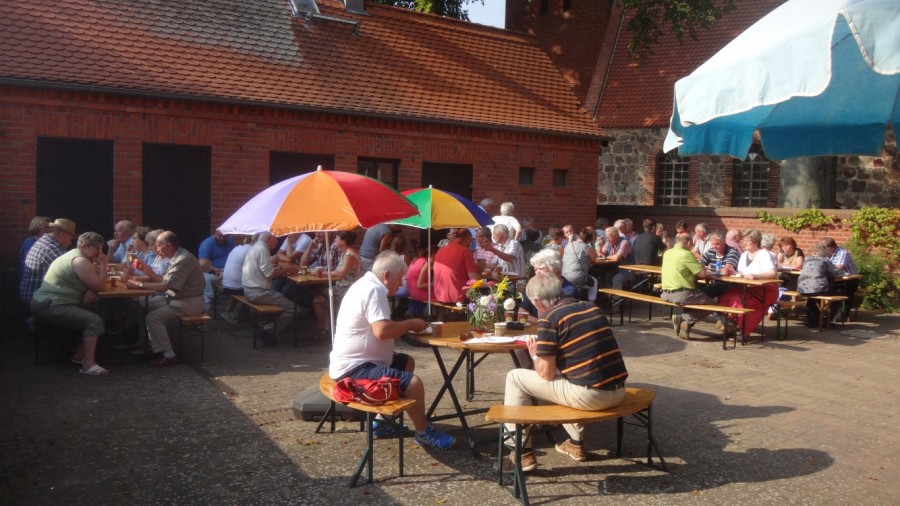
[{"x1": 328, "y1": 272, "x2": 394, "y2": 379}]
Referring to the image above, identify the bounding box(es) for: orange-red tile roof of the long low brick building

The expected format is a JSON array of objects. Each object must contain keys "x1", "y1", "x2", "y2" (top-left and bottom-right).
[{"x1": 0, "y1": 0, "x2": 603, "y2": 137}]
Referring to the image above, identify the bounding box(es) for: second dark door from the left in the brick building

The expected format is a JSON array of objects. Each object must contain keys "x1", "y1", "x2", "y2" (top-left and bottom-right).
[{"x1": 143, "y1": 144, "x2": 212, "y2": 255}]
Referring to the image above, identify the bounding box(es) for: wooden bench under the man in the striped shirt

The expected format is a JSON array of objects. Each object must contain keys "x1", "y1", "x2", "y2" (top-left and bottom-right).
[{"x1": 485, "y1": 388, "x2": 668, "y2": 505}]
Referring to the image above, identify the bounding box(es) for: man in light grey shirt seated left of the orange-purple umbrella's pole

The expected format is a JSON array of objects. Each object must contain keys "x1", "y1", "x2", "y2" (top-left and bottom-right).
[{"x1": 241, "y1": 232, "x2": 300, "y2": 346}]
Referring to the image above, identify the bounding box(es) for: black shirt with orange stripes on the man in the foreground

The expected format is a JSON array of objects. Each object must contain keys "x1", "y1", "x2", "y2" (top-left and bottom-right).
[{"x1": 536, "y1": 298, "x2": 628, "y2": 388}]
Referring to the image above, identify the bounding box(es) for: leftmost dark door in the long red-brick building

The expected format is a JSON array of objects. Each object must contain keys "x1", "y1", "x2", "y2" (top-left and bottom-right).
[{"x1": 37, "y1": 137, "x2": 114, "y2": 244}]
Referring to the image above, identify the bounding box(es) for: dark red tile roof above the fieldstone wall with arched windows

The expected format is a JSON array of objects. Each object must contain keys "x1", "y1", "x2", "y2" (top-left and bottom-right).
[{"x1": 597, "y1": 0, "x2": 785, "y2": 128}]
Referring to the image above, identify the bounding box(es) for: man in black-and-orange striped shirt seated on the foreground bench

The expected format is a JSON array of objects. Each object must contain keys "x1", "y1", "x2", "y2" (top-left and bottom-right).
[{"x1": 503, "y1": 274, "x2": 628, "y2": 472}]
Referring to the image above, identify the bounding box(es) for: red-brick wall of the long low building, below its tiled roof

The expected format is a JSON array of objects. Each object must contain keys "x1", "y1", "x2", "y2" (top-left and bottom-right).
[{"x1": 0, "y1": 86, "x2": 600, "y2": 259}]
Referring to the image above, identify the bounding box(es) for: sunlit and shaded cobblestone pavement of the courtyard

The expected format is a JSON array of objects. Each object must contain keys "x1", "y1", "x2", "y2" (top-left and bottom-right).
[{"x1": 0, "y1": 306, "x2": 900, "y2": 505}]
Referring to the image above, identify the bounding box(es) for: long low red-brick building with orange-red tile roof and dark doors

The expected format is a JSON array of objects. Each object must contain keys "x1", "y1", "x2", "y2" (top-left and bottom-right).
[{"x1": 0, "y1": 0, "x2": 604, "y2": 260}]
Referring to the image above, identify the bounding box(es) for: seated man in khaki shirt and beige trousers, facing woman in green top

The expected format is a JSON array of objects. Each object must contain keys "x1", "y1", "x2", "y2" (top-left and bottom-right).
[{"x1": 127, "y1": 230, "x2": 203, "y2": 367}]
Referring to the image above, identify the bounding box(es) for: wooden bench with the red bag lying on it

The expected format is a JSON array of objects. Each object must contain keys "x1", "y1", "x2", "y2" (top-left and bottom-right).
[{"x1": 316, "y1": 373, "x2": 416, "y2": 488}]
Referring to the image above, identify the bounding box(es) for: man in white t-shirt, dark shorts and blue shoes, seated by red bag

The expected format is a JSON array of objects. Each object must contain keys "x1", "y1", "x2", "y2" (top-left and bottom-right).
[{"x1": 328, "y1": 251, "x2": 458, "y2": 449}]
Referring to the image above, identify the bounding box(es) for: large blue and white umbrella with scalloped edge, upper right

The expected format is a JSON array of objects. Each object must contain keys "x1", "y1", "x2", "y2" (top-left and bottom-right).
[{"x1": 664, "y1": 0, "x2": 900, "y2": 160}]
